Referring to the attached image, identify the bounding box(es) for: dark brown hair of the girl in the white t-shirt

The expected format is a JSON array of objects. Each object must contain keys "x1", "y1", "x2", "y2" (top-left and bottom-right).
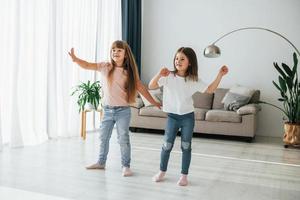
[{"x1": 173, "y1": 47, "x2": 198, "y2": 81}]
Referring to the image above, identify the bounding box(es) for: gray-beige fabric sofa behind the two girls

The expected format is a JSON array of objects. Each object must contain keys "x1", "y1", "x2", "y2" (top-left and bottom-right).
[{"x1": 130, "y1": 88, "x2": 260, "y2": 141}]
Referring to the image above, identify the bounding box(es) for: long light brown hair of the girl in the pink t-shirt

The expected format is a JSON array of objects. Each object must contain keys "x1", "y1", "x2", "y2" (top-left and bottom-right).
[{"x1": 108, "y1": 40, "x2": 139, "y2": 103}]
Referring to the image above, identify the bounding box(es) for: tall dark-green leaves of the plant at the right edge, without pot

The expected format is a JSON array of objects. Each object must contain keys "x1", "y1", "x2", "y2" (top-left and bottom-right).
[{"x1": 260, "y1": 53, "x2": 300, "y2": 124}]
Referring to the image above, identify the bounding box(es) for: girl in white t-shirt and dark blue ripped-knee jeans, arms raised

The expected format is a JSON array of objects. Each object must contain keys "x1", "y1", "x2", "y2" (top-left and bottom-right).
[{"x1": 149, "y1": 47, "x2": 228, "y2": 186}]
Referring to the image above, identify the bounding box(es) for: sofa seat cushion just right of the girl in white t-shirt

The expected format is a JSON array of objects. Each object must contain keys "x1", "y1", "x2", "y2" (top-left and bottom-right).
[{"x1": 205, "y1": 110, "x2": 242, "y2": 123}]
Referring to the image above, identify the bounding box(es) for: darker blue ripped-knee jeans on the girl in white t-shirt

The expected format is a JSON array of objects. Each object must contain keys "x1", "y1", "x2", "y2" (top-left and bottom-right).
[{"x1": 160, "y1": 112, "x2": 195, "y2": 174}]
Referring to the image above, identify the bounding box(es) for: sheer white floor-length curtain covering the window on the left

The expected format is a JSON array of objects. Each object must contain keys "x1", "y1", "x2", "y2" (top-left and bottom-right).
[{"x1": 0, "y1": 0, "x2": 121, "y2": 147}]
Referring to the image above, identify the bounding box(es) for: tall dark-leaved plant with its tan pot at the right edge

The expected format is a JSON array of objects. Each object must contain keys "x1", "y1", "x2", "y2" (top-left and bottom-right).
[{"x1": 260, "y1": 53, "x2": 300, "y2": 148}]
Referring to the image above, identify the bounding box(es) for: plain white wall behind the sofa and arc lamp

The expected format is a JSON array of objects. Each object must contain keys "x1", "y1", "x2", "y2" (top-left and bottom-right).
[{"x1": 141, "y1": 0, "x2": 300, "y2": 137}]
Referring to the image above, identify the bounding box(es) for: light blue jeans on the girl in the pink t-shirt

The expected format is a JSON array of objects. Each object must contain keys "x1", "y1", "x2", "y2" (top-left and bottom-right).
[{"x1": 98, "y1": 106, "x2": 131, "y2": 167}]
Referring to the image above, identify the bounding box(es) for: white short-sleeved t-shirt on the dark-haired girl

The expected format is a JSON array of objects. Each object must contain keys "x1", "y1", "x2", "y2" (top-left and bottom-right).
[{"x1": 158, "y1": 73, "x2": 207, "y2": 115}]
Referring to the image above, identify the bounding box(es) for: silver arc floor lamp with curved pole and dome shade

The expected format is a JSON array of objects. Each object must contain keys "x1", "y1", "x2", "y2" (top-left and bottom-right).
[{"x1": 204, "y1": 27, "x2": 300, "y2": 58}]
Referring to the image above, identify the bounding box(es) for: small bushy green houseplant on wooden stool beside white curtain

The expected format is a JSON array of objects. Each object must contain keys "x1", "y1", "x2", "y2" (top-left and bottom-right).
[{"x1": 71, "y1": 81, "x2": 101, "y2": 112}]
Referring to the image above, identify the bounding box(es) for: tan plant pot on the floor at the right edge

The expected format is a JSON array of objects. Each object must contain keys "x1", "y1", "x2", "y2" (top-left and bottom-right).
[{"x1": 283, "y1": 123, "x2": 300, "y2": 145}]
